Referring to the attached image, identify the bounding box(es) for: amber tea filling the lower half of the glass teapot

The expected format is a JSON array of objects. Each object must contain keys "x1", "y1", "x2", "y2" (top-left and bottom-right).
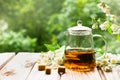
[{"x1": 64, "y1": 49, "x2": 96, "y2": 71}]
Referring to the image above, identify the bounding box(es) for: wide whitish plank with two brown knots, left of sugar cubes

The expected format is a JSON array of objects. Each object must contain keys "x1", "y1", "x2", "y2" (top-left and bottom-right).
[{"x1": 0, "y1": 53, "x2": 38, "y2": 80}]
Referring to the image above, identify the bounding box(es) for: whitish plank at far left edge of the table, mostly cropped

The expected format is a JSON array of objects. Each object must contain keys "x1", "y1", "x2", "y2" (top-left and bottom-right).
[{"x1": 0, "y1": 53, "x2": 15, "y2": 69}]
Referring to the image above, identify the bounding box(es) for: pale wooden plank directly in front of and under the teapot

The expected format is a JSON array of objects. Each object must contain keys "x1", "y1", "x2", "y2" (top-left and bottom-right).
[{"x1": 62, "y1": 69, "x2": 101, "y2": 80}]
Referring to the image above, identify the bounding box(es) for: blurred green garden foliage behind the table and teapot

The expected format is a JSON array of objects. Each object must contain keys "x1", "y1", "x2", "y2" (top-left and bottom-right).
[{"x1": 0, "y1": 0, "x2": 120, "y2": 52}]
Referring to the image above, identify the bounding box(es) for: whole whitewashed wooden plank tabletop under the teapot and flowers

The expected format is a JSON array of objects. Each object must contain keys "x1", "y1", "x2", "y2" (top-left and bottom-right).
[{"x1": 0, "y1": 52, "x2": 120, "y2": 80}]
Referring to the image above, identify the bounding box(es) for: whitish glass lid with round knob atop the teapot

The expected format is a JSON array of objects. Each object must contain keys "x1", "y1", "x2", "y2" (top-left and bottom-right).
[{"x1": 68, "y1": 20, "x2": 92, "y2": 35}]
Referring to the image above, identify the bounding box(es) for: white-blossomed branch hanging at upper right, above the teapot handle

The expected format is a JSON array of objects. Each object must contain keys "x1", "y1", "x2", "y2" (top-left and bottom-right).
[{"x1": 92, "y1": 2, "x2": 120, "y2": 34}]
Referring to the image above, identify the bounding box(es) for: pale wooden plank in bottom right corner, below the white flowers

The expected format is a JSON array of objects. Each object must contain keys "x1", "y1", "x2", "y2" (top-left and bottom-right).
[{"x1": 103, "y1": 68, "x2": 120, "y2": 80}]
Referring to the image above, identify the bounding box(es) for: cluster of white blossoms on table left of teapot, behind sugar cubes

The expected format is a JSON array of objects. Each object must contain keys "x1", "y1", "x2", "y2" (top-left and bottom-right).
[{"x1": 36, "y1": 46, "x2": 65, "y2": 69}]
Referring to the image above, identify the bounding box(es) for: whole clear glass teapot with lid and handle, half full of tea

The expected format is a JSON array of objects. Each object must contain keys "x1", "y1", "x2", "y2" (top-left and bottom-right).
[{"x1": 64, "y1": 21, "x2": 107, "y2": 72}]
